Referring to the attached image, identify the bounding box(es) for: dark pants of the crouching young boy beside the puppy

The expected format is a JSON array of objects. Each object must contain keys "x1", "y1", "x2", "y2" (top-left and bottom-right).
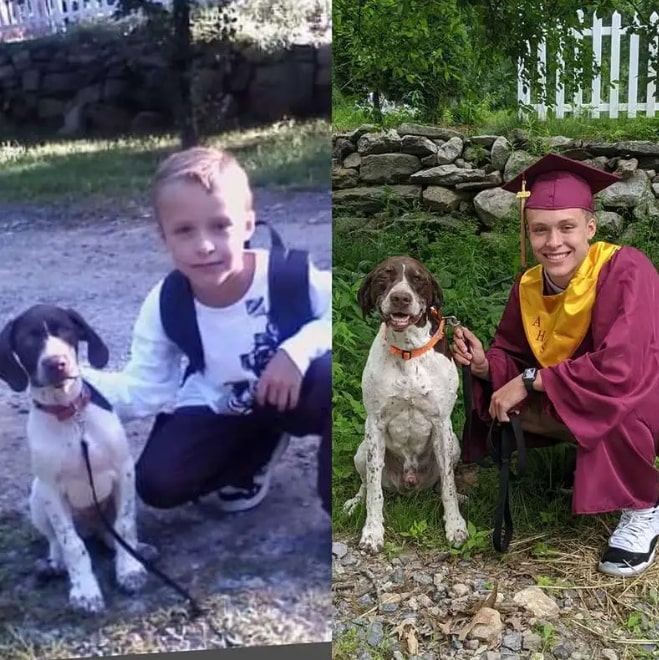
[{"x1": 135, "y1": 353, "x2": 332, "y2": 513}]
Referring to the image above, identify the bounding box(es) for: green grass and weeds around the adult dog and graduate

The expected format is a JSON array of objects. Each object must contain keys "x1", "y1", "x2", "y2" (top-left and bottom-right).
[{"x1": 333, "y1": 210, "x2": 659, "y2": 556}]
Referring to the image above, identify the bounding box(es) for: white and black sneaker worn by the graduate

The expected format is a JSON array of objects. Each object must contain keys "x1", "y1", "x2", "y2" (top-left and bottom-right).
[{"x1": 598, "y1": 506, "x2": 659, "y2": 577}]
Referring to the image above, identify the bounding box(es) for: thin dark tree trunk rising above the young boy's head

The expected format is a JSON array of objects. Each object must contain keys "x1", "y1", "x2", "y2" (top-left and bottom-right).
[{"x1": 172, "y1": 0, "x2": 199, "y2": 149}]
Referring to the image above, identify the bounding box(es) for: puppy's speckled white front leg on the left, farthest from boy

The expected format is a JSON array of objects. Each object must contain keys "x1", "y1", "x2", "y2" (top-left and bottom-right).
[{"x1": 35, "y1": 481, "x2": 105, "y2": 612}]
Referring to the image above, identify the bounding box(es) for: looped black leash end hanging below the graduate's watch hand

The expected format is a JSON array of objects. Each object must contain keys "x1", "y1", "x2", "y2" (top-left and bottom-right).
[{"x1": 487, "y1": 414, "x2": 526, "y2": 552}]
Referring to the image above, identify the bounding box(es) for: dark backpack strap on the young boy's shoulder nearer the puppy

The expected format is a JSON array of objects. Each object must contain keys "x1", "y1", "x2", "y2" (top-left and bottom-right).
[{"x1": 160, "y1": 270, "x2": 206, "y2": 381}]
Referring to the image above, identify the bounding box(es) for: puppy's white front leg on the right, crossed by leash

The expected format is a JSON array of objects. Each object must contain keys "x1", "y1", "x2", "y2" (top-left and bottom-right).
[{"x1": 115, "y1": 456, "x2": 147, "y2": 594}]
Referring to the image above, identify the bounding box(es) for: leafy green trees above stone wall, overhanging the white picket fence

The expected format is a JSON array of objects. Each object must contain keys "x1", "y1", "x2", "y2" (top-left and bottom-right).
[{"x1": 333, "y1": 0, "x2": 659, "y2": 121}]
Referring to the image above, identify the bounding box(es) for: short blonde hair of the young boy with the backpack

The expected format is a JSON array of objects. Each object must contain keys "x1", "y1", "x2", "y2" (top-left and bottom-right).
[{"x1": 152, "y1": 147, "x2": 252, "y2": 215}]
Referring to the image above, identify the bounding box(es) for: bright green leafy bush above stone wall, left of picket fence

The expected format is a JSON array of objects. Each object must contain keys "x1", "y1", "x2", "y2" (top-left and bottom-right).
[{"x1": 333, "y1": 0, "x2": 490, "y2": 121}]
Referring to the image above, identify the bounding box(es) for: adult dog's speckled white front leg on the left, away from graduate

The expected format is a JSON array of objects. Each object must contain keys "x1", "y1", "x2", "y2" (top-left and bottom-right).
[{"x1": 359, "y1": 416, "x2": 385, "y2": 553}]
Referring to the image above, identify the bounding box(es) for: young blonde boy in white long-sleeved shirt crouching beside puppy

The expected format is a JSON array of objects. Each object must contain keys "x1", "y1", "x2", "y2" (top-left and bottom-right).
[{"x1": 84, "y1": 147, "x2": 331, "y2": 512}]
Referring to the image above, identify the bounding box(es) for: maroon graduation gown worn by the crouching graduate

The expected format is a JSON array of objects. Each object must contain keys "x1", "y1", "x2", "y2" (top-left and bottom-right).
[{"x1": 462, "y1": 247, "x2": 659, "y2": 513}]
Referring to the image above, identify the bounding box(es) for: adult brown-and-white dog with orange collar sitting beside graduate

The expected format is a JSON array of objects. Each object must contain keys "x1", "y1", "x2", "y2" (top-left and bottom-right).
[{"x1": 344, "y1": 256, "x2": 468, "y2": 553}]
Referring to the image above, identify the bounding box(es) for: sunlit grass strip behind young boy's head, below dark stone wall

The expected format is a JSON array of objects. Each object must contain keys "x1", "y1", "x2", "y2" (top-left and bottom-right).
[{"x1": 0, "y1": 121, "x2": 331, "y2": 202}]
